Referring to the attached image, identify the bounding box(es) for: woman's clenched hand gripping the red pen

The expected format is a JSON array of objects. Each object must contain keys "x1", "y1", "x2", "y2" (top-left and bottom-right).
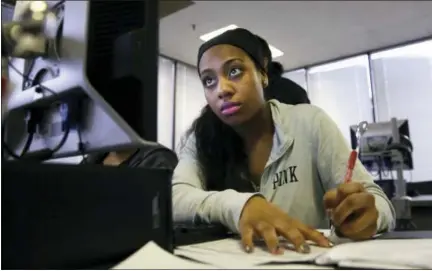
[{"x1": 324, "y1": 182, "x2": 378, "y2": 240}]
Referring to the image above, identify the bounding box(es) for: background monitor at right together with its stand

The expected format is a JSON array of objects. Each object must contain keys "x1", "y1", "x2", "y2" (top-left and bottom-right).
[{"x1": 350, "y1": 118, "x2": 415, "y2": 230}]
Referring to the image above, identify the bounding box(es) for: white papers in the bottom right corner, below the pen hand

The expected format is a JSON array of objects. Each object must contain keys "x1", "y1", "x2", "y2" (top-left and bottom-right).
[{"x1": 316, "y1": 239, "x2": 432, "y2": 269}]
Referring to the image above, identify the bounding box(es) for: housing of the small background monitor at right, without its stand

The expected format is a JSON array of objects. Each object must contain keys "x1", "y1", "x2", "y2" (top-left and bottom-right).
[{"x1": 350, "y1": 119, "x2": 414, "y2": 170}]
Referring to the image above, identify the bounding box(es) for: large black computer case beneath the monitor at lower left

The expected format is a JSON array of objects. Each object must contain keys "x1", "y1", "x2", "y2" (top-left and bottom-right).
[{"x1": 1, "y1": 161, "x2": 173, "y2": 269}]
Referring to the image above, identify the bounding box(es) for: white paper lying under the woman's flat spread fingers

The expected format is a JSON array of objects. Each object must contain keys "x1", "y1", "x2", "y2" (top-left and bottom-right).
[{"x1": 175, "y1": 239, "x2": 329, "y2": 269}]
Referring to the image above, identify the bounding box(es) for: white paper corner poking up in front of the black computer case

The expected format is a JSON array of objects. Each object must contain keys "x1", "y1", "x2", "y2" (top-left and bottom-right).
[{"x1": 113, "y1": 242, "x2": 215, "y2": 269}]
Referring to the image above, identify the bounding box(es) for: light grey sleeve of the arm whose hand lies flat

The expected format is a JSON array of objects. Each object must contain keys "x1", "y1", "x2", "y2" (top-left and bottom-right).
[{"x1": 172, "y1": 135, "x2": 256, "y2": 233}]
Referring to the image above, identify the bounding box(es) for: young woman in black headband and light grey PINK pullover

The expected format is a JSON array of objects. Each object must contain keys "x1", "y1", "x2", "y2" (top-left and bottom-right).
[{"x1": 173, "y1": 29, "x2": 394, "y2": 253}]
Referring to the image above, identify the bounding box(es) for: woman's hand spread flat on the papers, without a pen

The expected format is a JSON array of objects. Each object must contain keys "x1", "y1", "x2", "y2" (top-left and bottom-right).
[{"x1": 239, "y1": 196, "x2": 331, "y2": 254}]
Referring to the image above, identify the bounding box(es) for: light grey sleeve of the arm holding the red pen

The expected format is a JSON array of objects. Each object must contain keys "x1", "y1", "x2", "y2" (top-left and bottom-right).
[{"x1": 314, "y1": 109, "x2": 395, "y2": 232}]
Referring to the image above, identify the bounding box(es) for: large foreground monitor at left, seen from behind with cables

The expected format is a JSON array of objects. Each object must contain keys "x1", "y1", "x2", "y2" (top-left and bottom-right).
[{"x1": 4, "y1": 1, "x2": 159, "y2": 160}]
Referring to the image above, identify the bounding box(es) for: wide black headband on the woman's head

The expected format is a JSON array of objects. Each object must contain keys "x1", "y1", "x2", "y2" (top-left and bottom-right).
[{"x1": 197, "y1": 28, "x2": 265, "y2": 74}]
